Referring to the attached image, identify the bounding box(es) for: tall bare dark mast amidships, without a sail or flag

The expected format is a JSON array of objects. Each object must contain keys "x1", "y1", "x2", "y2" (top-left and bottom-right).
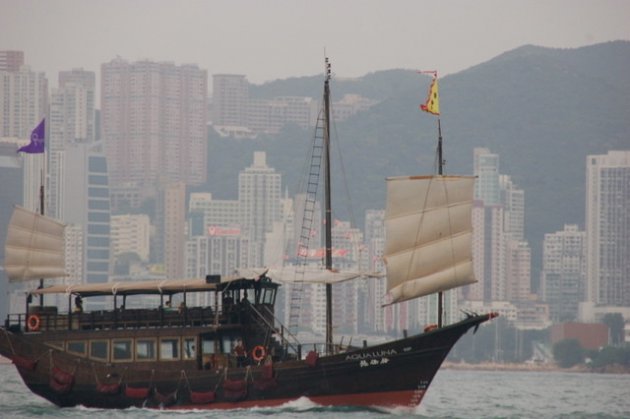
[{"x1": 324, "y1": 57, "x2": 333, "y2": 354}]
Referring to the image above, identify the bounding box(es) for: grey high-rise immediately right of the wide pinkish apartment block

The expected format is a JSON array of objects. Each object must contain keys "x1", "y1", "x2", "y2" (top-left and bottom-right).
[{"x1": 212, "y1": 74, "x2": 249, "y2": 127}]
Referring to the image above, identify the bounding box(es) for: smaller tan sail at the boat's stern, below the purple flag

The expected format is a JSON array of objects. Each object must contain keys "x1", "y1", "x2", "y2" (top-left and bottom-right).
[{"x1": 4, "y1": 206, "x2": 66, "y2": 281}]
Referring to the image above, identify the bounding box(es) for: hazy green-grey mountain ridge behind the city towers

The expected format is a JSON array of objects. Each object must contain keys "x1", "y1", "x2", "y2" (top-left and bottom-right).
[{"x1": 197, "y1": 41, "x2": 630, "y2": 282}]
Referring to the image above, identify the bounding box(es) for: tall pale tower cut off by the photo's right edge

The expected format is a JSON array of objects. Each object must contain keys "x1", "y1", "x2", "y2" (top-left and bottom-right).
[{"x1": 586, "y1": 150, "x2": 630, "y2": 307}]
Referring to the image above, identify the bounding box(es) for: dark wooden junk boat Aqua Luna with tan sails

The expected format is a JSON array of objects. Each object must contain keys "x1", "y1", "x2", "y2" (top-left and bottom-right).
[{"x1": 0, "y1": 61, "x2": 495, "y2": 409}]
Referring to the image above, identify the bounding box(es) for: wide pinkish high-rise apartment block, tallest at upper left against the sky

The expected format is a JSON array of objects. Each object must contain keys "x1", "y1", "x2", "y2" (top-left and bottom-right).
[{"x1": 101, "y1": 58, "x2": 208, "y2": 205}]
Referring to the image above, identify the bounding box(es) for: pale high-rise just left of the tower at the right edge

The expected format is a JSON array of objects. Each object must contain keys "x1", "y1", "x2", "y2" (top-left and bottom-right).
[{"x1": 540, "y1": 224, "x2": 586, "y2": 323}]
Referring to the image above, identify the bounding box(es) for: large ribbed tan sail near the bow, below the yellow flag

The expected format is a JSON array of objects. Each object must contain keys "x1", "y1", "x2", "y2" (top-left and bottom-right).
[{"x1": 385, "y1": 175, "x2": 477, "y2": 303}]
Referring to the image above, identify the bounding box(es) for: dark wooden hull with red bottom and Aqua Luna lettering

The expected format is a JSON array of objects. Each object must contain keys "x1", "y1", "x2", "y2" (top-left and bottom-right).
[{"x1": 0, "y1": 315, "x2": 492, "y2": 409}]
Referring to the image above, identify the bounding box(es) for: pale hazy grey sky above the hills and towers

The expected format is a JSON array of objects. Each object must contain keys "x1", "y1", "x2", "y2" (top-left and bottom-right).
[{"x1": 0, "y1": 0, "x2": 630, "y2": 87}]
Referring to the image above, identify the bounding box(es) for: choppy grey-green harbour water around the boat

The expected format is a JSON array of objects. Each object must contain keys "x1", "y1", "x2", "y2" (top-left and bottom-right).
[{"x1": 0, "y1": 365, "x2": 630, "y2": 419}]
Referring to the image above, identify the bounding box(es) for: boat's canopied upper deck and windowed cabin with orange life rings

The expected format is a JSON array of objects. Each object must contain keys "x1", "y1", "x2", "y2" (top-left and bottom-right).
[{"x1": 5, "y1": 275, "x2": 295, "y2": 369}]
